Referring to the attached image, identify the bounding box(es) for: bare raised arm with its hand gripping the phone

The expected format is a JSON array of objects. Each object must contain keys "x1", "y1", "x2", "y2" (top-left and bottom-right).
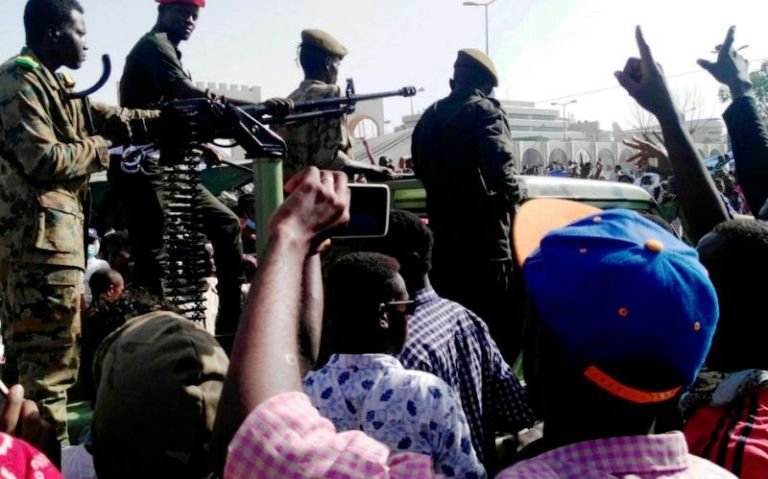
[{"x1": 213, "y1": 168, "x2": 349, "y2": 468}]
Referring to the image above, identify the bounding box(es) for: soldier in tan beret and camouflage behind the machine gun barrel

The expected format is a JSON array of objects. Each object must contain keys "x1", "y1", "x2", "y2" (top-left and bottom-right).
[{"x1": 273, "y1": 29, "x2": 394, "y2": 182}]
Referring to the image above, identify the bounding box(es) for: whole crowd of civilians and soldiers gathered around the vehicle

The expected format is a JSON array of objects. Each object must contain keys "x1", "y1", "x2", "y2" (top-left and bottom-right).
[{"x1": 0, "y1": 0, "x2": 768, "y2": 479}]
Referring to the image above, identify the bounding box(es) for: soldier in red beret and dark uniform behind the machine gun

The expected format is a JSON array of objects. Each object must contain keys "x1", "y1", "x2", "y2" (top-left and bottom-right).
[{"x1": 110, "y1": 0, "x2": 290, "y2": 334}]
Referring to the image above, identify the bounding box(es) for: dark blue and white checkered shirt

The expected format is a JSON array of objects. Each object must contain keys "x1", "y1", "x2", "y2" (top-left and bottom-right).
[{"x1": 399, "y1": 286, "x2": 534, "y2": 461}]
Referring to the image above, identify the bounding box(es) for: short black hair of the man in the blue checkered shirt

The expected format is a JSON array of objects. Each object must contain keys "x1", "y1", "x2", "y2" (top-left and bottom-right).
[{"x1": 365, "y1": 210, "x2": 435, "y2": 273}]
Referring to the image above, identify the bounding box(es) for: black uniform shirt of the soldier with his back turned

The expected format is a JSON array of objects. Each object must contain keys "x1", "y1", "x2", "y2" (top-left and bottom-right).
[{"x1": 412, "y1": 90, "x2": 517, "y2": 262}]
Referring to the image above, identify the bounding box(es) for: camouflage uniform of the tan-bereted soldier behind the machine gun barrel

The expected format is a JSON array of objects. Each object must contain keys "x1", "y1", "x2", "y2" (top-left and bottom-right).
[{"x1": 274, "y1": 80, "x2": 352, "y2": 181}]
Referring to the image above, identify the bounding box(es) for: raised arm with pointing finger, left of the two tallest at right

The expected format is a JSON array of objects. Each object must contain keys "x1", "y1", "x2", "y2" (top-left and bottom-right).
[{"x1": 616, "y1": 27, "x2": 730, "y2": 242}]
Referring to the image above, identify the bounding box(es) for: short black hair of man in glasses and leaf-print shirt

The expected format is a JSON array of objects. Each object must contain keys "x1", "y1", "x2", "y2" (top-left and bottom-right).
[{"x1": 325, "y1": 253, "x2": 400, "y2": 343}]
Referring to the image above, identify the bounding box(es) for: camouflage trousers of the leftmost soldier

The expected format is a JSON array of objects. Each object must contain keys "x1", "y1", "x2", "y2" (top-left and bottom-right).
[{"x1": 3, "y1": 263, "x2": 82, "y2": 444}]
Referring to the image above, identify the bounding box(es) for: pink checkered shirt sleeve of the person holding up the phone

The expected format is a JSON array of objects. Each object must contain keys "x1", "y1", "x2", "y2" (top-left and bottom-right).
[{"x1": 224, "y1": 392, "x2": 439, "y2": 479}]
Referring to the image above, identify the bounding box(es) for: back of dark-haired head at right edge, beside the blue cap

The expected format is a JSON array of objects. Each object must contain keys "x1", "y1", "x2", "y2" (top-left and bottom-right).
[{"x1": 701, "y1": 220, "x2": 768, "y2": 372}]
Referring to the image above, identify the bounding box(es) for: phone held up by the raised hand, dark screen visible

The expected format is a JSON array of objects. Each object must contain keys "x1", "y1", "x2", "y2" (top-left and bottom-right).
[{"x1": 333, "y1": 184, "x2": 389, "y2": 238}]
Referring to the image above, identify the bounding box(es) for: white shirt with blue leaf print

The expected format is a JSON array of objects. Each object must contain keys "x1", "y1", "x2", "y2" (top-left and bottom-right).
[{"x1": 304, "y1": 354, "x2": 486, "y2": 478}]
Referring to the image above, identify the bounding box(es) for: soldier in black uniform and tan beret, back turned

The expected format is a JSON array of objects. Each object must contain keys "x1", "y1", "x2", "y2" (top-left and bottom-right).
[{"x1": 412, "y1": 49, "x2": 520, "y2": 363}]
